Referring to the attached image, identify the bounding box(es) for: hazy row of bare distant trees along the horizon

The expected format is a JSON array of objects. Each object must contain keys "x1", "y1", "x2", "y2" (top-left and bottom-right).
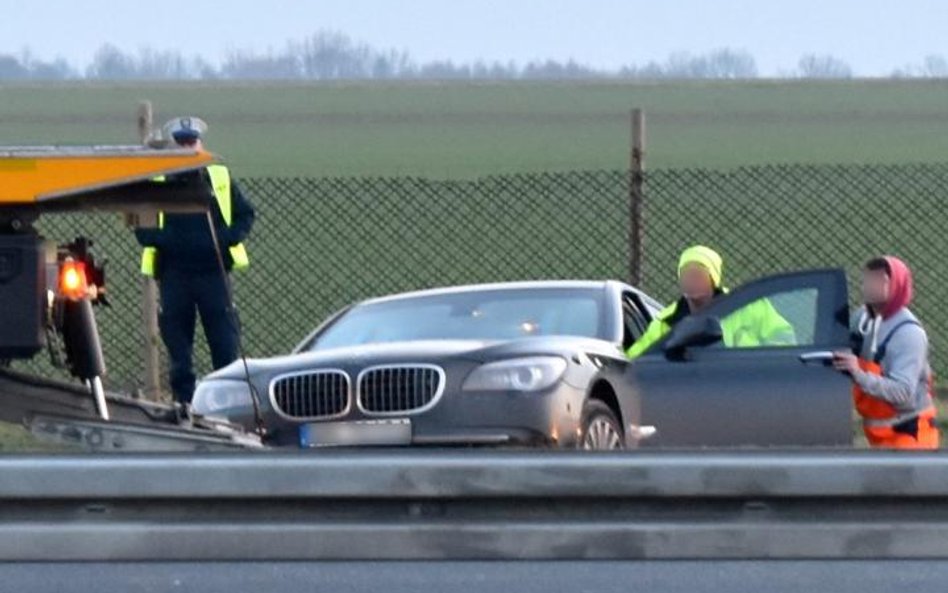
[{"x1": 0, "y1": 31, "x2": 948, "y2": 81}]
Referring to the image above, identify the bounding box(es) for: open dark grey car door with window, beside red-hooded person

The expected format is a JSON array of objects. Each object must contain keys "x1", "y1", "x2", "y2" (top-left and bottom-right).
[{"x1": 625, "y1": 269, "x2": 853, "y2": 447}]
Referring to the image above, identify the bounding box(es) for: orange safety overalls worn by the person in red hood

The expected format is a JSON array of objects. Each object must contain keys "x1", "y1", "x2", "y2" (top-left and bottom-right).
[{"x1": 853, "y1": 322, "x2": 940, "y2": 449}]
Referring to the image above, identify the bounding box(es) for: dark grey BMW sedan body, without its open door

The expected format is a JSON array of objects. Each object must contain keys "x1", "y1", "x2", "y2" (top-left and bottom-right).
[{"x1": 193, "y1": 281, "x2": 659, "y2": 448}]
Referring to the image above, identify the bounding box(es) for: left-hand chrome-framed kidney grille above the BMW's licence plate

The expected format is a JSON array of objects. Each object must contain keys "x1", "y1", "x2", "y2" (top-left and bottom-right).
[{"x1": 270, "y1": 370, "x2": 350, "y2": 420}]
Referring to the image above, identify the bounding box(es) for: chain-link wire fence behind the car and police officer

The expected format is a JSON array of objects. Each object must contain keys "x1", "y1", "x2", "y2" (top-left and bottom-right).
[{"x1": 18, "y1": 164, "x2": 948, "y2": 396}]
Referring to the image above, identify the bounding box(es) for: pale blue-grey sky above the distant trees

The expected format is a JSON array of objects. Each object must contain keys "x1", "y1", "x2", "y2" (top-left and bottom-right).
[{"x1": 0, "y1": 0, "x2": 948, "y2": 76}]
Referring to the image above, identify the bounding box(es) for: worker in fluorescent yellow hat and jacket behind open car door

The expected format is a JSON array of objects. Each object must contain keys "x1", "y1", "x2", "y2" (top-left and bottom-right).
[{"x1": 626, "y1": 245, "x2": 796, "y2": 358}]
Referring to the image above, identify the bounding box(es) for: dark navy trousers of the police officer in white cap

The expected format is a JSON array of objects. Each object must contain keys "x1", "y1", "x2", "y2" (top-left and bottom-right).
[{"x1": 158, "y1": 270, "x2": 239, "y2": 403}]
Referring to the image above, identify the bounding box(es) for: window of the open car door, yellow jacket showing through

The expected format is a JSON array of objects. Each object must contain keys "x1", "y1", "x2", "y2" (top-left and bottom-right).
[{"x1": 718, "y1": 288, "x2": 819, "y2": 348}]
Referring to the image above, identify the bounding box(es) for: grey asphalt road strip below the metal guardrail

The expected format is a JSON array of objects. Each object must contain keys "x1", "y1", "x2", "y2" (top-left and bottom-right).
[{"x1": 7, "y1": 561, "x2": 948, "y2": 593}]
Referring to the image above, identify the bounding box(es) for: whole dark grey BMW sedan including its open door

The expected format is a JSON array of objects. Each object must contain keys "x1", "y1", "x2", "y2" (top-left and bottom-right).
[{"x1": 192, "y1": 270, "x2": 851, "y2": 449}]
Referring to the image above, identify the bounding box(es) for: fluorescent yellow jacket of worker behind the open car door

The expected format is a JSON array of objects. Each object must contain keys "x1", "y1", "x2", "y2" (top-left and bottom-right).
[{"x1": 625, "y1": 298, "x2": 797, "y2": 358}]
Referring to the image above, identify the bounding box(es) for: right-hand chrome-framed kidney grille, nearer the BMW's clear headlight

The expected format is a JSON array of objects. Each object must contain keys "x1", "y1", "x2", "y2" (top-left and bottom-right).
[{"x1": 359, "y1": 365, "x2": 444, "y2": 415}]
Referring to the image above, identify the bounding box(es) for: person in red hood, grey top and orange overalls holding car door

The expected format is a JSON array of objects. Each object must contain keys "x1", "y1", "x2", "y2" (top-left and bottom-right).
[{"x1": 834, "y1": 256, "x2": 939, "y2": 449}]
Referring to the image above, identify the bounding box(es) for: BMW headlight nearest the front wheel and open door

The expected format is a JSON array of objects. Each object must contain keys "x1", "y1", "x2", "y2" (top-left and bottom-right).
[{"x1": 461, "y1": 356, "x2": 566, "y2": 391}]
